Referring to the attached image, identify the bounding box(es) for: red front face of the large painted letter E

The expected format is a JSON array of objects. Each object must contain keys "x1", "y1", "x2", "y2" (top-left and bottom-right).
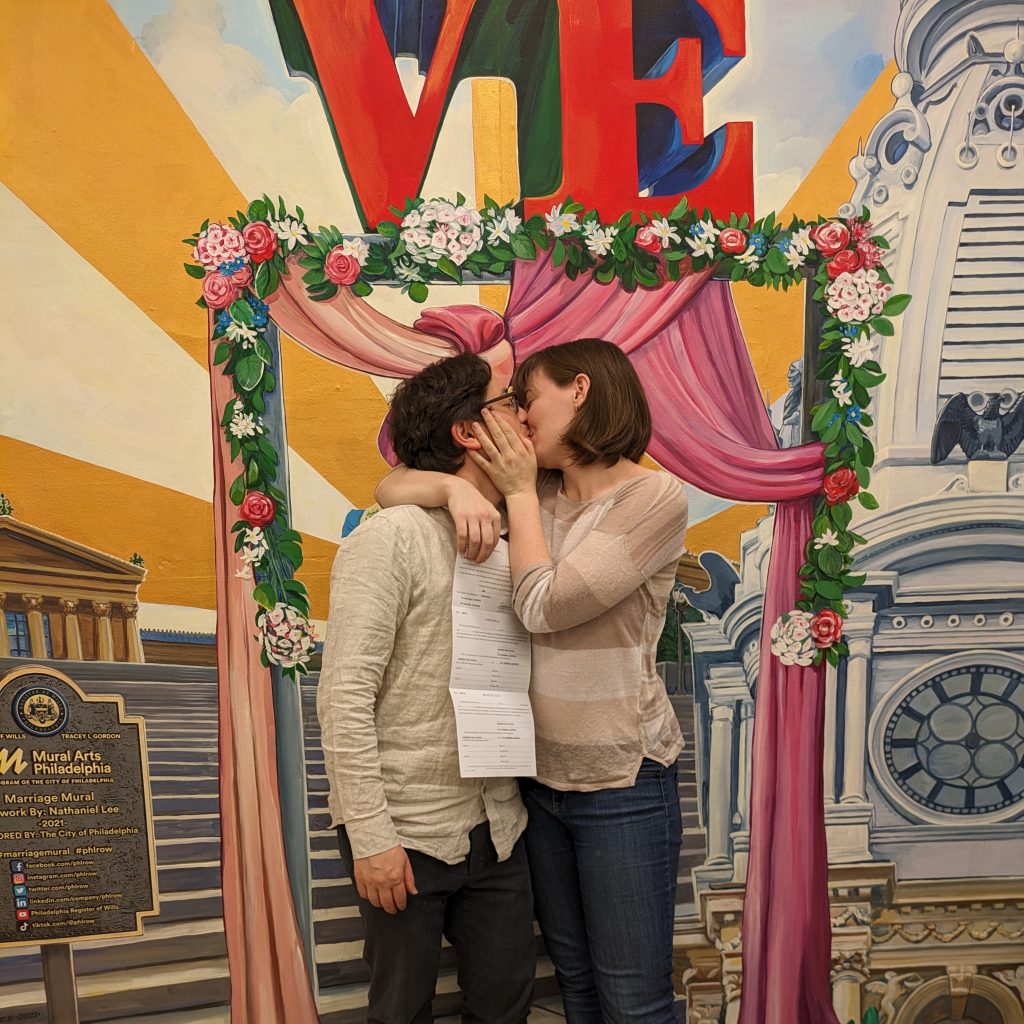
[{"x1": 526, "y1": 0, "x2": 754, "y2": 220}]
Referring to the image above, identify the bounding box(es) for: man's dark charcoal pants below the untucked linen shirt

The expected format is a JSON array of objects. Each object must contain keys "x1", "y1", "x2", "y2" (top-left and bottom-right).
[{"x1": 338, "y1": 821, "x2": 537, "y2": 1024}]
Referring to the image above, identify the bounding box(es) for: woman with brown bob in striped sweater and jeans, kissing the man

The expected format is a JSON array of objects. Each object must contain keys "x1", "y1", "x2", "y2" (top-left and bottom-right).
[{"x1": 378, "y1": 338, "x2": 686, "y2": 1024}]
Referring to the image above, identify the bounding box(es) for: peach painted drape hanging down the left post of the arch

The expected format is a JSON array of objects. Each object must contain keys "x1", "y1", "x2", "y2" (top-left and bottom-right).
[{"x1": 210, "y1": 327, "x2": 319, "y2": 1024}]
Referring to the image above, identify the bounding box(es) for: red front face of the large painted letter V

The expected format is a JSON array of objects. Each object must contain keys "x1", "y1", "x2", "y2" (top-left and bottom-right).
[{"x1": 295, "y1": 0, "x2": 476, "y2": 228}]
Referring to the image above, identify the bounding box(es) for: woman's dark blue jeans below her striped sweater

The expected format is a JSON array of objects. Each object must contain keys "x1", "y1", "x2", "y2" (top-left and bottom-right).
[{"x1": 519, "y1": 758, "x2": 682, "y2": 1024}]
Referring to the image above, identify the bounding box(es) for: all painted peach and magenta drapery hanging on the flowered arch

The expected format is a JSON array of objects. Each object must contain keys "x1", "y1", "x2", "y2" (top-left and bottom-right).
[{"x1": 211, "y1": 253, "x2": 836, "y2": 1024}]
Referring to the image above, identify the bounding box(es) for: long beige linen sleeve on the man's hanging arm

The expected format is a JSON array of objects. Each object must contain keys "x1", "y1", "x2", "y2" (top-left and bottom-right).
[{"x1": 317, "y1": 519, "x2": 412, "y2": 857}]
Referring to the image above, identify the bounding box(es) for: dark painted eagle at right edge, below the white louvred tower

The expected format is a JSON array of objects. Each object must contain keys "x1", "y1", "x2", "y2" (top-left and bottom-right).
[{"x1": 932, "y1": 388, "x2": 1024, "y2": 466}]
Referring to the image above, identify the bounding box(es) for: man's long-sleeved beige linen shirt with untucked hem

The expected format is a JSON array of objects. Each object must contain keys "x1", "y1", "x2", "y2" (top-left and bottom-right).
[{"x1": 316, "y1": 505, "x2": 526, "y2": 864}]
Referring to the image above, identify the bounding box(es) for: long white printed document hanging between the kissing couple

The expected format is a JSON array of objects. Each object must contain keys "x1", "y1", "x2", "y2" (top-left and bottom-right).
[{"x1": 449, "y1": 541, "x2": 537, "y2": 778}]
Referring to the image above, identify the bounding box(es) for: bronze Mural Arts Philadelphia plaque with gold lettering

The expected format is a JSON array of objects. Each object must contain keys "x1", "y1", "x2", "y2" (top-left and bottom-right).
[{"x1": 0, "y1": 666, "x2": 158, "y2": 945}]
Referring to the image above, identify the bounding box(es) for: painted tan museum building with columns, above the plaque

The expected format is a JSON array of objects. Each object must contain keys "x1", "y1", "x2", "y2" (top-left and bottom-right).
[{"x1": 0, "y1": 504, "x2": 145, "y2": 662}]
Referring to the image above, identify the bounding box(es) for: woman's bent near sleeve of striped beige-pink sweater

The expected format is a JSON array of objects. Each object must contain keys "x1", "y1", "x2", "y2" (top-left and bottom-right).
[{"x1": 512, "y1": 474, "x2": 686, "y2": 633}]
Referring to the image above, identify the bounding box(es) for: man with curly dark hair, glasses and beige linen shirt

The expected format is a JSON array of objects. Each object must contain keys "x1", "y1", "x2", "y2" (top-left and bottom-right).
[{"x1": 317, "y1": 353, "x2": 536, "y2": 1024}]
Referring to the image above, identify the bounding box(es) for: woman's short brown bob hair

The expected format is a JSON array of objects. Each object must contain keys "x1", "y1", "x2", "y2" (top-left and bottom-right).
[{"x1": 512, "y1": 338, "x2": 651, "y2": 466}]
